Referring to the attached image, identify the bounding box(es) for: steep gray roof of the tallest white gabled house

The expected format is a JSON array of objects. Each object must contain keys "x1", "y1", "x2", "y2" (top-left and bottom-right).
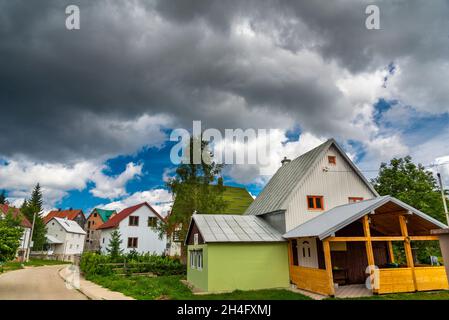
[{"x1": 245, "y1": 139, "x2": 378, "y2": 215}]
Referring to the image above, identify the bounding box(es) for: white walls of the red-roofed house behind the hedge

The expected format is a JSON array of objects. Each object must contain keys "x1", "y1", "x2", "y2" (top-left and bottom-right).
[{"x1": 100, "y1": 206, "x2": 167, "y2": 255}]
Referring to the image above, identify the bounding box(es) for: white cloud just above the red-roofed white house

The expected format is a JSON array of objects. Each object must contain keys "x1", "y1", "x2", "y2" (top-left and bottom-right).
[{"x1": 97, "y1": 189, "x2": 173, "y2": 216}]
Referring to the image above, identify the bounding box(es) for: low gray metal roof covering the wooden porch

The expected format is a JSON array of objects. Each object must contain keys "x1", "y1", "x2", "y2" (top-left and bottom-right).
[{"x1": 283, "y1": 196, "x2": 447, "y2": 240}]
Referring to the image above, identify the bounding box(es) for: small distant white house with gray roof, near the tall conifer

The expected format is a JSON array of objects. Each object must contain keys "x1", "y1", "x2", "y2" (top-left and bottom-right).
[{"x1": 46, "y1": 218, "x2": 86, "y2": 260}]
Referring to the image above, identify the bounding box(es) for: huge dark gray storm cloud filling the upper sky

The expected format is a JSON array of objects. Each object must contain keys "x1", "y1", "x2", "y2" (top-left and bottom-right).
[{"x1": 0, "y1": 0, "x2": 447, "y2": 161}]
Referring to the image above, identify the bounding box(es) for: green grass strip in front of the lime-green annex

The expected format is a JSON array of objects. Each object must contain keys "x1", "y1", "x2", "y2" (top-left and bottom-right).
[{"x1": 87, "y1": 276, "x2": 310, "y2": 300}]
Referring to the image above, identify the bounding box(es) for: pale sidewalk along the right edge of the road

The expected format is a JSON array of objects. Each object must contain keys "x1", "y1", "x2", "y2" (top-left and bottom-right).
[{"x1": 59, "y1": 266, "x2": 135, "y2": 300}]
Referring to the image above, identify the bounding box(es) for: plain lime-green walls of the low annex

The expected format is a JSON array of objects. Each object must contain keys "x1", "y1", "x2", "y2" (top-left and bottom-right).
[{"x1": 187, "y1": 242, "x2": 290, "y2": 292}]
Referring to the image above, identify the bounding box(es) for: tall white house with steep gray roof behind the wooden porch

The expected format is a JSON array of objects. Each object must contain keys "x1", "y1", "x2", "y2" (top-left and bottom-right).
[{"x1": 245, "y1": 139, "x2": 378, "y2": 268}]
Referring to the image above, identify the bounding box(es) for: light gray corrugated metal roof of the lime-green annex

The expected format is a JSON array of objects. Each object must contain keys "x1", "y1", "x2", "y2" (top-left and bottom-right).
[{"x1": 192, "y1": 214, "x2": 285, "y2": 243}]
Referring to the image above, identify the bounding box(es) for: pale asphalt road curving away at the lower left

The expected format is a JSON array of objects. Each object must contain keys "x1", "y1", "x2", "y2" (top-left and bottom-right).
[{"x1": 0, "y1": 266, "x2": 87, "y2": 300}]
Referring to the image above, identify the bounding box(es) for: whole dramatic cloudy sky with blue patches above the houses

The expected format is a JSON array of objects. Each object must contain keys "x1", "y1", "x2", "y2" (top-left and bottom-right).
[{"x1": 0, "y1": 0, "x2": 449, "y2": 215}]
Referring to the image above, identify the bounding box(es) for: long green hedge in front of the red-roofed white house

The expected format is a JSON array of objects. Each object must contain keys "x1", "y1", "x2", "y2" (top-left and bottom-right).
[{"x1": 80, "y1": 251, "x2": 186, "y2": 276}]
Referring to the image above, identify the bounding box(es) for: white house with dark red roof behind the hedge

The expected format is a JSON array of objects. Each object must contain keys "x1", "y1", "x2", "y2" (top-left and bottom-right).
[{"x1": 98, "y1": 202, "x2": 167, "y2": 254}]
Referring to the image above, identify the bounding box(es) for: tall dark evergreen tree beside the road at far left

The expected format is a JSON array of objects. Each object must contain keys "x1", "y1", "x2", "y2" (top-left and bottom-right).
[{"x1": 21, "y1": 183, "x2": 47, "y2": 250}]
